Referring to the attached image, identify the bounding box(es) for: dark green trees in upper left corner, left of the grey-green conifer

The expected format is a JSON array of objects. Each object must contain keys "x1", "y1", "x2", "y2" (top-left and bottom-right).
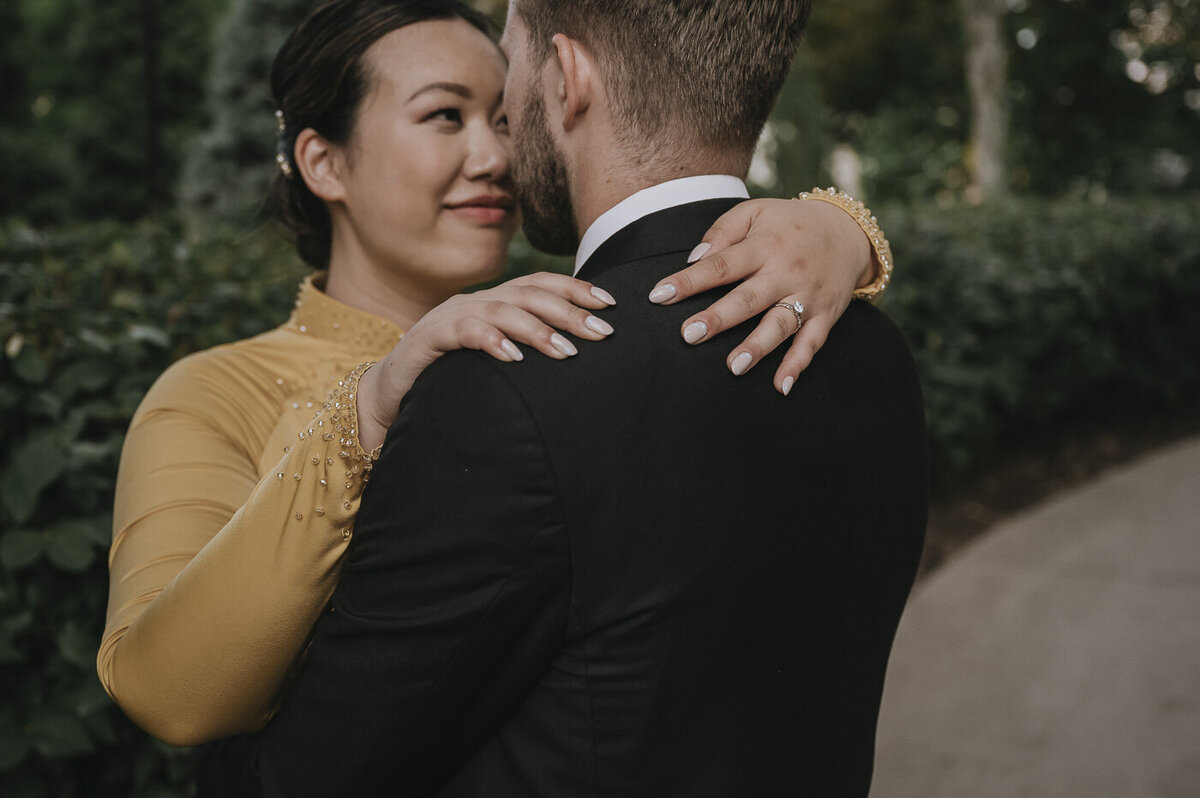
[{"x1": 0, "y1": 0, "x2": 227, "y2": 223}]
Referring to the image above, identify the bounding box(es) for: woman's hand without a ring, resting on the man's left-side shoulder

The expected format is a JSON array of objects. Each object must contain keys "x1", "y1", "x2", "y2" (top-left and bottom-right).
[{"x1": 356, "y1": 272, "x2": 617, "y2": 451}]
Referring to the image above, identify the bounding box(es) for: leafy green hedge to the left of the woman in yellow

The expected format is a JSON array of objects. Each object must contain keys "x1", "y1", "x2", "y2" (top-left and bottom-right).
[{"x1": 0, "y1": 218, "x2": 302, "y2": 798}]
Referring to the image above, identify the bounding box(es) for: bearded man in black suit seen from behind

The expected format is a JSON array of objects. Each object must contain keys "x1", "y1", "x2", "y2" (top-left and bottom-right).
[{"x1": 202, "y1": 0, "x2": 925, "y2": 798}]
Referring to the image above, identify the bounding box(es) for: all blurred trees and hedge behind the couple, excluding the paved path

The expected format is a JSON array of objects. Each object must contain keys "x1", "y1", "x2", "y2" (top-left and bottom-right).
[{"x1": 0, "y1": 0, "x2": 1200, "y2": 798}]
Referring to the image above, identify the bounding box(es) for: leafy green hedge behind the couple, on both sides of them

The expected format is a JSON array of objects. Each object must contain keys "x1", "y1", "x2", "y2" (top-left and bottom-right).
[{"x1": 0, "y1": 198, "x2": 1200, "y2": 798}]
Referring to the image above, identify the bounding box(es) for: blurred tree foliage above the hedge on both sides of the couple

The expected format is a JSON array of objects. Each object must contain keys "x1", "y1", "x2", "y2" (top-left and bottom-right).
[{"x1": 7, "y1": 0, "x2": 1200, "y2": 224}]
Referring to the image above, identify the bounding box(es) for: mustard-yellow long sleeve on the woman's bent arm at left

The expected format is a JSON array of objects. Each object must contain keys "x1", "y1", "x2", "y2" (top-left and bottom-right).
[{"x1": 97, "y1": 357, "x2": 373, "y2": 745}]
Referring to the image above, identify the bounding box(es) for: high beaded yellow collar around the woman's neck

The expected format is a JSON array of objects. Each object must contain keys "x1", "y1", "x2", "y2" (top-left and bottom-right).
[{"x1": 284, "y1": 271, "x2": 404, "y2": 356}]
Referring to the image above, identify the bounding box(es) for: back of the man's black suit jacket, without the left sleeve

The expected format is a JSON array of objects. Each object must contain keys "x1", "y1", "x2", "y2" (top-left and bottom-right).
[{"x1": 422, "y1": 200, "x2": 925, "y2": 796}]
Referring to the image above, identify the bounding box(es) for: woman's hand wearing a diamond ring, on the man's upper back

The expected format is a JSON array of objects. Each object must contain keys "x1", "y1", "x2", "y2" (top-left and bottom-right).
[{"x1": 650, "y1": 199, "x2": 875, "y2": 395}]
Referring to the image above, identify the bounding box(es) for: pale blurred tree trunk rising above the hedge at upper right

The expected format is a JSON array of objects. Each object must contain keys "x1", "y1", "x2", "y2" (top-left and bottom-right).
[{"x1": 960, "y1": 0, "x2": 1009, "y2": 199}]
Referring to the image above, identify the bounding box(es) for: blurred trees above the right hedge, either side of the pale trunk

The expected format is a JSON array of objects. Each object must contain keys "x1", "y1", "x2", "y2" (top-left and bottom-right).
[{"x1": 805, "y1": 0, "x2": 1200, "y2": 203}]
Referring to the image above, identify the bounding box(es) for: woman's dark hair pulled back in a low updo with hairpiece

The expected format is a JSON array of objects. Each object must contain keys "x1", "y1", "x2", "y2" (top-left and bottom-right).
[{"x1": 270, "y1": 0, "x2": 493, "y2": 269}]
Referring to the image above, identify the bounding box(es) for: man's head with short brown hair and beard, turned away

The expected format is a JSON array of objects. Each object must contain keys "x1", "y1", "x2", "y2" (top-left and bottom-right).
[{"x1": 504, "y1": 0, "x2": 811, "y2": 251}]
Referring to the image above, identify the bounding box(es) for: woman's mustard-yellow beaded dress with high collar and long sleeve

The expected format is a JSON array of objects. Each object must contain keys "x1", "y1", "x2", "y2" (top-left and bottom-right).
[{"x1": 97, "y1": 275, "x2": 402, "y2": 745}]
